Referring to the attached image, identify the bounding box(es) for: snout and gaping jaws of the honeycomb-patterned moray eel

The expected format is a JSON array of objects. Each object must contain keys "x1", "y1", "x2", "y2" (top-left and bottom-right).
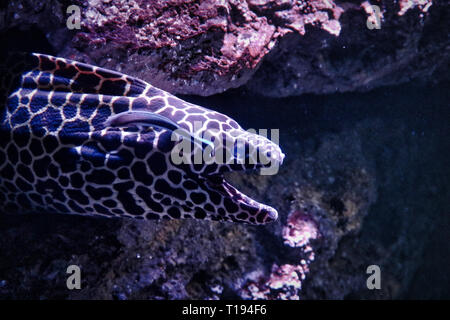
[{"x1": 172, "y1": 126, "x2": 285, "y2": 224}]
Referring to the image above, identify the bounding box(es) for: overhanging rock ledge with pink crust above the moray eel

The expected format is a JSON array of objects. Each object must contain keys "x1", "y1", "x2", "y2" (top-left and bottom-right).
[{"x1": 0, "y1": 0, "x2": 450, "y2": 97}]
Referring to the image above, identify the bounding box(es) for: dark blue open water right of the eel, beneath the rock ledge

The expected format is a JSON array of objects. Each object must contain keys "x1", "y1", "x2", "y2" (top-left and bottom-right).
[{"x1": 183, "y1": 83, "x2": 450, "y2": 299}]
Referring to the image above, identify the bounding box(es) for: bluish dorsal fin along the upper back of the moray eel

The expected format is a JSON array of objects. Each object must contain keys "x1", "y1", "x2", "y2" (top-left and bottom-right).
[{"x1": 0, "y1": 52, "x2": 169, "y2": 130}]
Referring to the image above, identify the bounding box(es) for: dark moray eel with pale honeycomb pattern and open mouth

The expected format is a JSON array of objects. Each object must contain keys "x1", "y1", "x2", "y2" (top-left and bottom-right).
[{"x1": 0, "y1": 53, "x2": 284, "y2": 224}]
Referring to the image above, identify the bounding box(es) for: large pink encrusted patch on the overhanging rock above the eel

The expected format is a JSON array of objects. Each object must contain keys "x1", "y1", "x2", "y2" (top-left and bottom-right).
[{"x1": 76, "y1": 0, "x2": 343, "y2": 78}]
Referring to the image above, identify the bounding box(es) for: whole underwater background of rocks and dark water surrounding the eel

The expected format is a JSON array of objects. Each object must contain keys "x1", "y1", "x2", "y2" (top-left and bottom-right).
[{"x1": 0, "y1": 0, "x2": 450, "y2": 300}]
